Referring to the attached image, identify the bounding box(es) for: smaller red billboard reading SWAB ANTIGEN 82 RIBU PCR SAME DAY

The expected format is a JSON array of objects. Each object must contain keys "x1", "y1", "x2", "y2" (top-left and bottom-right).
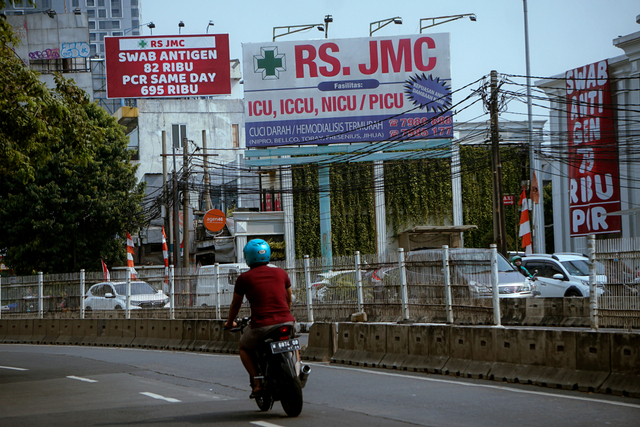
[{"x1": 104, "y1": 34, "x2": 231, "y2": 98}]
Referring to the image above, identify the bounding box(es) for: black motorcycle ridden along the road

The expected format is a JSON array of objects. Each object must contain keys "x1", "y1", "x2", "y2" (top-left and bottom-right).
[{"x1": 230, "y1": 317, "x2": 311, "y2": 417}]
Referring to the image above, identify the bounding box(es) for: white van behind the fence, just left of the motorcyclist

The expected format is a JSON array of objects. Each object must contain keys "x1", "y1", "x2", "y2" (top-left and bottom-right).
[{"x1": 196, "y1": 263, "x2": 249, "y2": 307}]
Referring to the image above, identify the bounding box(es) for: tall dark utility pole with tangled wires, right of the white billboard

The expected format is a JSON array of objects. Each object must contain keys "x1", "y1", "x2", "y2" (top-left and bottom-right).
[{"x1": 489, "y1": 70, "x2": 507, "y2": 256}]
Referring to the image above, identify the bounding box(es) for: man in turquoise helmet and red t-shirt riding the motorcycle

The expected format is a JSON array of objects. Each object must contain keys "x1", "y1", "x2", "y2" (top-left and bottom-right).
[{"x1": 225, "y1": 239, "x2": 295, "y2": 398}]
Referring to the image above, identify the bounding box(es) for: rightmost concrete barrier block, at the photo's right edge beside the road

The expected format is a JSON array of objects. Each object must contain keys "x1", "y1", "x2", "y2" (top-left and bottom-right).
[{"x1": 600, "y1": 332, "x2": 640, "y2": 398}]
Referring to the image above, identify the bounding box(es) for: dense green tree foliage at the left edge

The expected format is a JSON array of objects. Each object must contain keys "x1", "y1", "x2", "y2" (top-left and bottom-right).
[{"x1": 0, "y1": 43, "x2": 144, "y2": 274}]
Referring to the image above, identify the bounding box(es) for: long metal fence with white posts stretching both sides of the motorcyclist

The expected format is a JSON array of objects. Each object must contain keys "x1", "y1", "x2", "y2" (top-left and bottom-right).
[{"x1": 0, "y1": 248, "x2": 499, "y2": 324}]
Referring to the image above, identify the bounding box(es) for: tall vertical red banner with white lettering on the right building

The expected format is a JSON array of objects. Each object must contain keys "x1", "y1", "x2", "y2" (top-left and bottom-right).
[{"x1": 565, "y1": 60, "x2": 620, "y2": 237}]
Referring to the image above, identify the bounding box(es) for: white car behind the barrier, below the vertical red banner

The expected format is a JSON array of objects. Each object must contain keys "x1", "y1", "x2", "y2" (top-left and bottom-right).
[{"x1": 522, "y1": 253, "x2": 607, "y2": 297}]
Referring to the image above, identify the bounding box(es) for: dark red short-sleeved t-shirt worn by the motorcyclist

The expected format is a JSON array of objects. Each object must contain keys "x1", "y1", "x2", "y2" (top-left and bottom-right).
[{"x1": 234, "y1": 265, "x2": 296, "y2": 328}]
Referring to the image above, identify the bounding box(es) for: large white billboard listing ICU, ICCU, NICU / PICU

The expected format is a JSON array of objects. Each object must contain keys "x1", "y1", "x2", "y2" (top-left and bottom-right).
[{"x1": 242, "y1": 33, "x2": 453, "y2": 147}]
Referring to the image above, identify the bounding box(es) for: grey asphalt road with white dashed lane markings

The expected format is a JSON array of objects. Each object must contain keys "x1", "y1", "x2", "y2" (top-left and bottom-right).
[{"x1": 0, "y1": 345, "x2": 640, "y2": 427}]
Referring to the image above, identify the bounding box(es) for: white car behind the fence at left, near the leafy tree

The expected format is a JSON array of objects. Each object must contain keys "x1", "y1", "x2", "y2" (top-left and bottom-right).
[{"x1": 85, "y1": 281, "x2": 169, "y2": 310}]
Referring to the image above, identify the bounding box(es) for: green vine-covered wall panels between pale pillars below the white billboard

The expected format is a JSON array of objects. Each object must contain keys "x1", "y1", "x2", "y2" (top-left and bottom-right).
[{"x1": 293, "y1": 145, "x2": 528, "y2": 258}]
